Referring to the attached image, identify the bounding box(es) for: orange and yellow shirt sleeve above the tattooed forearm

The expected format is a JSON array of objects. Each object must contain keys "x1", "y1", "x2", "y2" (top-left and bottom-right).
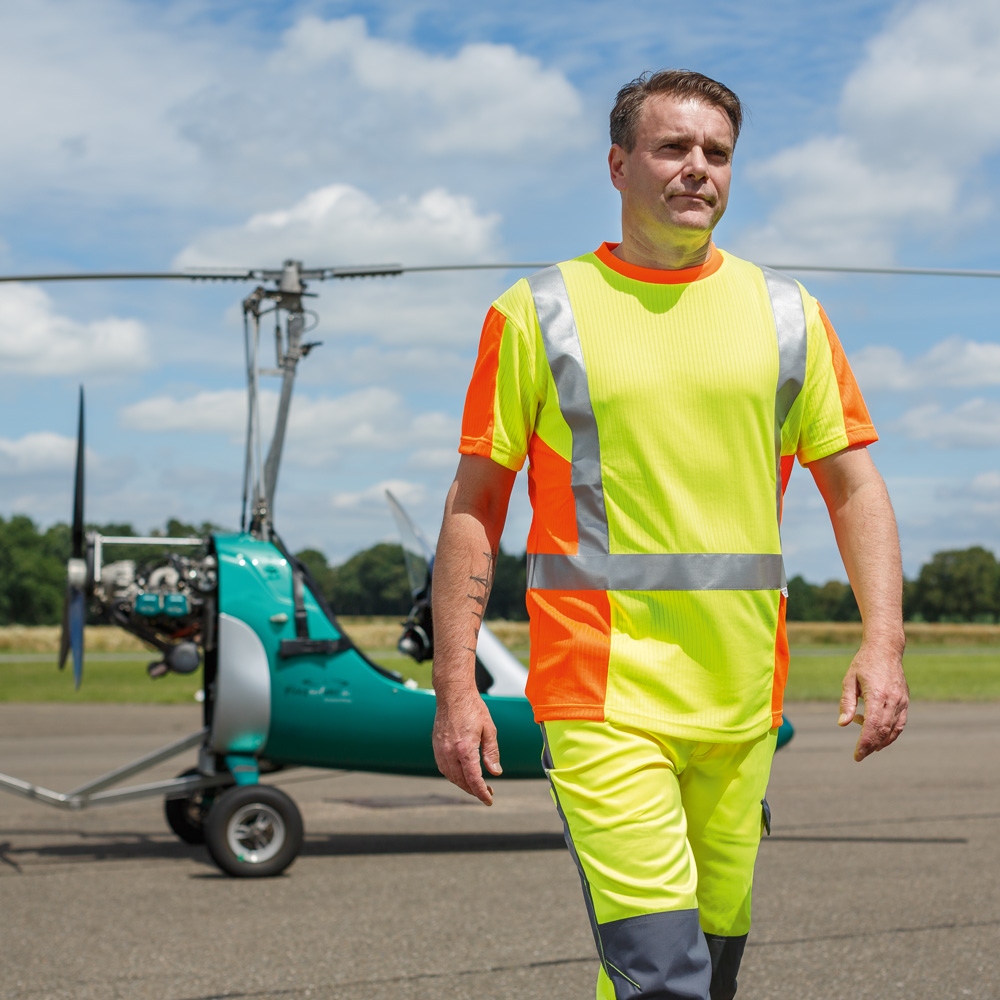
[{"x1": 458, "y1": 294, "x2": 539, "y2": 471}]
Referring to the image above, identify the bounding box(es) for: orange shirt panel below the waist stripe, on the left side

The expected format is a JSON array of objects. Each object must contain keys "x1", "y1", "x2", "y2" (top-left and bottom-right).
[{"x1": 525, "y1": 590, "x2": 611, "y2": 722}]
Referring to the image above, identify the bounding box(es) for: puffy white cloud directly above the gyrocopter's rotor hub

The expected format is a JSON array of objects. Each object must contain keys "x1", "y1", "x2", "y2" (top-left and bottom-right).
[{"x1": 174, "y1": 184, "x2": 500, "y2": 268}]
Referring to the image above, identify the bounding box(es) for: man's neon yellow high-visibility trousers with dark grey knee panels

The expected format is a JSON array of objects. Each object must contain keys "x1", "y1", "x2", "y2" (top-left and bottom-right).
[{"x1": 542, "y1": 720, "x2": 777, "y2": 1000}]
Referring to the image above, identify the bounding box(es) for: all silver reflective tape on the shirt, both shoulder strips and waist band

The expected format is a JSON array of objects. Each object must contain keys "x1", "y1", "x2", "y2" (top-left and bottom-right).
[{"x1": 528, "y1": 266, "x2": 806, "y2": 590}]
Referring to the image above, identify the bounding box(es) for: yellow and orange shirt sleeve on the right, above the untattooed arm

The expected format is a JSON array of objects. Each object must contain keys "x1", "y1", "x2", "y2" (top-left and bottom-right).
[{"x1": 782, "y1": 294, "x2": 878, "y2": 465}]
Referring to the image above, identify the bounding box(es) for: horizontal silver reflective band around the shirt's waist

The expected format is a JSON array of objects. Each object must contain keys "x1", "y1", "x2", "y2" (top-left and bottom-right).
[{"x1": 528, "y1": 552, "x2": 784, "y2": 590}]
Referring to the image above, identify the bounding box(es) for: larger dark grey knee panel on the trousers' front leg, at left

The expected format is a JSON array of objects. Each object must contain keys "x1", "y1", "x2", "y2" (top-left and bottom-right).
[{"x1": 598, "y1": 909, "x2": 712, "y2": 1000}]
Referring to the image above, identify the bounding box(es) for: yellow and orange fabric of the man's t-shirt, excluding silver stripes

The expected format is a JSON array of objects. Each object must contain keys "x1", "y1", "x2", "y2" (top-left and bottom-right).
[{"x1": 459, "y1": 244, "x2": 878, "y2": 742}]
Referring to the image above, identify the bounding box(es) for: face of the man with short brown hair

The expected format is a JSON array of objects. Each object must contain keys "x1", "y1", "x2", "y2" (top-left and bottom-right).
[{"x1": 608, "y1": 94, "x2": 733, "y2": 244}]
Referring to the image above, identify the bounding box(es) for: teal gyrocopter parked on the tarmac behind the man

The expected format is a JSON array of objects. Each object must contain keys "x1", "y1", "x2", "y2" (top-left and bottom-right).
[{"x1": 0, "y1": 261, "x2": 542, "y2": 876}]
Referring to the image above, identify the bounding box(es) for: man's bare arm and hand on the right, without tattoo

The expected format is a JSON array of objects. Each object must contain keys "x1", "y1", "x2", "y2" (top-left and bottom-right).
[{"x1": 808, "y1": 447, "x2": 910, "y2": 760}]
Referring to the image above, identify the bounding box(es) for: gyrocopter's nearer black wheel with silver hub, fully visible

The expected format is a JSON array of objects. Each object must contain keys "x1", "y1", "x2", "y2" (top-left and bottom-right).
[{"x1": 205, "y1": 785, "x2": 302, "y2": 878}]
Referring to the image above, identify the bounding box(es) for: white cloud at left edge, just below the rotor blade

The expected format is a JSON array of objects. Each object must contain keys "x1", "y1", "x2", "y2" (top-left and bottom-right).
[{"x1": 0, "y1": 284, "x2": 149, "y2": 375}]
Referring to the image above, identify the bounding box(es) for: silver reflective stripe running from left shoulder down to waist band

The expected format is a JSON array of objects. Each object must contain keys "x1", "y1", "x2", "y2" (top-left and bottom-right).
[{"x1": 528, "y1": 266, "x2": 608, "y2": 552}]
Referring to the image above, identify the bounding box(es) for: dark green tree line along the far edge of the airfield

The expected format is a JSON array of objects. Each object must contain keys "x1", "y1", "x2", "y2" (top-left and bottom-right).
[{"x1": 0, "y1": 515, "x2": 1000, "y2": 625}]
